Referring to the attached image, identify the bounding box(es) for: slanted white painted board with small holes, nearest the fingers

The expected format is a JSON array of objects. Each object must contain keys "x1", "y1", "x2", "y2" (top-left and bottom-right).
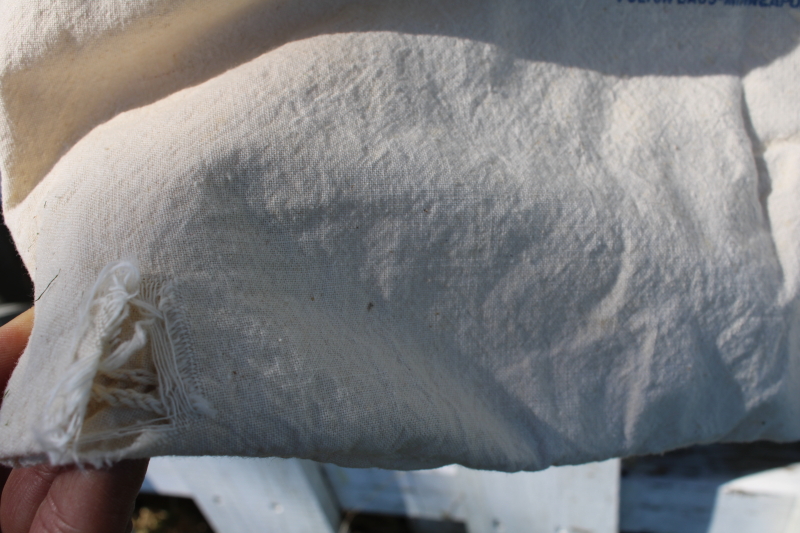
[{"x1": 147, "y1": 457, "x2": 340, "y2": 533}]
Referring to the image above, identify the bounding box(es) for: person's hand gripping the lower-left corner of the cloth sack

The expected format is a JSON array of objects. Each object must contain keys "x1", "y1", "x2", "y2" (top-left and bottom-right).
[{"x1": 0, "y1": 309, "x2": 148, "y2": 533}]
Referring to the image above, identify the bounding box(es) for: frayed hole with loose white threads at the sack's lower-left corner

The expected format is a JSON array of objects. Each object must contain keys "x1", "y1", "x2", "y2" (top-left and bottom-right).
[{"x1": 33, "y1": 260, "x2": 215, "y2": 466}]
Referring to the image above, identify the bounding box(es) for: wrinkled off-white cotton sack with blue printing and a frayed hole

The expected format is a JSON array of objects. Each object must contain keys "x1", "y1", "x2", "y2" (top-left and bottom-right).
[{"x1": 0, "y1": 0, "x2": 800, "y2": 471}]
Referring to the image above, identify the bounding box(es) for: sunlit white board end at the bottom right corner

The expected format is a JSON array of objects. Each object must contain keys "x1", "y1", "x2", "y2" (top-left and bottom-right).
[{"x1": 709, "y1": 464, "x2": 800, "y2": 533}]
